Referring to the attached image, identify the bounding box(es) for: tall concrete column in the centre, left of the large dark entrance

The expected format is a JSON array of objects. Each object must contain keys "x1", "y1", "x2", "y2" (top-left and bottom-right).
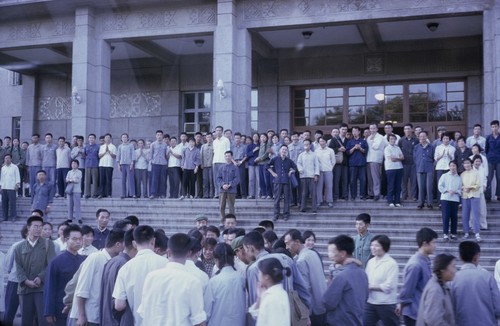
[{"x1": 212, "y1": 0, "x2": 252, "y2": 134}]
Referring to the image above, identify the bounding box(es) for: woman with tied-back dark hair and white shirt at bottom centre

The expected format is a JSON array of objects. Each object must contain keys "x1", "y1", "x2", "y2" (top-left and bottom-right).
[{"x1": 248, "y1": 258, "x2": 291, "y2": 326}]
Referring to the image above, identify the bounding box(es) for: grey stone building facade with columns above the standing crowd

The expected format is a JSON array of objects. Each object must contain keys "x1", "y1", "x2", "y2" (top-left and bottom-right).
[{"x1": 0, "y1": 0, "x2": 500, "y2": 140}]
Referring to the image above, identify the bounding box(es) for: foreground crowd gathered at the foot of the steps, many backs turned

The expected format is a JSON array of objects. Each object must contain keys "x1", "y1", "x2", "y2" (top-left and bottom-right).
[{"x1": 0, "y1": 209, "x2": 500, "y2": 326}]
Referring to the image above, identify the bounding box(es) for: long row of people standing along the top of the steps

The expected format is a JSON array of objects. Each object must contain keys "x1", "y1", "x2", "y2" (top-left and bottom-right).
[{"x1": 0, "y1": 120, "x2": 500, "y2": 237}]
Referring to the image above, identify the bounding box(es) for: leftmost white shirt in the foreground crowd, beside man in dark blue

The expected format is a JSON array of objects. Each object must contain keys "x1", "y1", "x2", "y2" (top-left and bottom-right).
[{"x1": 70, "y1": 249, "x2": 111, "y2": 324}]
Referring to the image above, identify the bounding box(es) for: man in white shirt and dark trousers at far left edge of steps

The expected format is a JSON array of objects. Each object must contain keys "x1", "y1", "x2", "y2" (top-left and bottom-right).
[{"x1": 0, "y1": 154, "x2": 21, "y2": 222}]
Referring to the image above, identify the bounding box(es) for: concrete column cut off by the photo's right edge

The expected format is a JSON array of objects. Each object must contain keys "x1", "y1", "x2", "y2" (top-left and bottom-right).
[{"x1": 482, "y1": 1, "x2": 500, "y2": 126}]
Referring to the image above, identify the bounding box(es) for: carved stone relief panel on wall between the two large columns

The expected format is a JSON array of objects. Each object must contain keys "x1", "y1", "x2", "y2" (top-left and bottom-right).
[{"x1": 109, "y1": 92, "x2": 161, "y2": 118}]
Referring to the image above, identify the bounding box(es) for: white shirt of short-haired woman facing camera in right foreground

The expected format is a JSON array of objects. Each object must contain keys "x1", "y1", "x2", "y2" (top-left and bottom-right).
[{"x1": 365, "y1": 254, "x2": 399, "y2": 304}]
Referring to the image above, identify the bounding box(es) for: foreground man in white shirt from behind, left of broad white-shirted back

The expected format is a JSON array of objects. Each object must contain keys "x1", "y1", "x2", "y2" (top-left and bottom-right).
[{"x1": 113, "y1": 225, "x2": 168, "y2": 326}]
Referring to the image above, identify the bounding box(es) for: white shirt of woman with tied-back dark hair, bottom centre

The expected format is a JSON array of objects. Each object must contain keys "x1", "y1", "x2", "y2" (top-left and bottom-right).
[{"x1": 248, "y1": 283, "x2": 291, "y2": 326}]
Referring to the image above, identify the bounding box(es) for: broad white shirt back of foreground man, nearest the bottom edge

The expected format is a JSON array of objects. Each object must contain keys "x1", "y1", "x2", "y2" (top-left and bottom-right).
[{"x1": 138, "y1": 262, "x2": 207, "y2": 326}]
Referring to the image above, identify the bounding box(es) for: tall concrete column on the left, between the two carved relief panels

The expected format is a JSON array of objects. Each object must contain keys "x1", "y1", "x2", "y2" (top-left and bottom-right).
[{"x1": 71, "y1": 7, "x2": 111, "y2": 136}]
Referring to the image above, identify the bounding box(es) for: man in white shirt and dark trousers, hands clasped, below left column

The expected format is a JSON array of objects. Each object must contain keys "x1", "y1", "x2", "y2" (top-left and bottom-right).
[{"x1": 97, "y1": 134, "x2": 116, "y2": 198}]
